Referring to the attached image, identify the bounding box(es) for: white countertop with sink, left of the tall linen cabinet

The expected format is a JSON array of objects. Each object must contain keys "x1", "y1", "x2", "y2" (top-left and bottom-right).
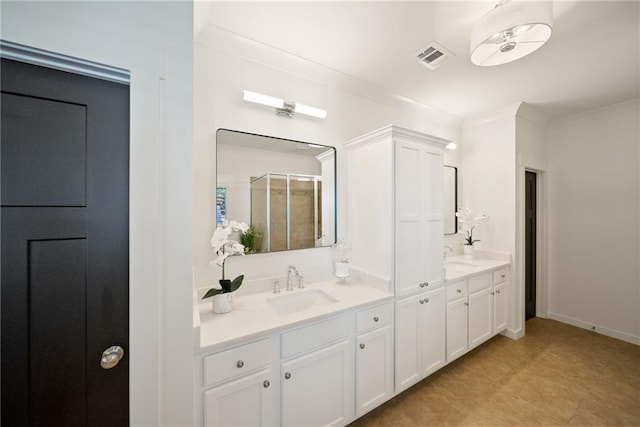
[{"x1": 194, "y1": 279, "x2": 393, "y2": 350}]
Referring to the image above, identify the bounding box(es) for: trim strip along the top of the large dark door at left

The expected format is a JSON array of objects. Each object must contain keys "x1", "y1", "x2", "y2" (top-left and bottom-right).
[{"x1": 0, "y1": 39, "x2": 131, "y2": 85}]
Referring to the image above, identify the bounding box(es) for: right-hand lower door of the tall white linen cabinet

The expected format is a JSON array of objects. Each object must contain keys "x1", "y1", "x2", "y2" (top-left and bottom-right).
[{"x1": 419, "y1": 288, "x2": 446, "y2": 378}]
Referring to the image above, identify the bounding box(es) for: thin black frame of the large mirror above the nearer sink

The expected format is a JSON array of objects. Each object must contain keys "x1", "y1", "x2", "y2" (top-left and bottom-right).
[{"x1": 214, "y1": 128, "x2": 338, "y2": 255}]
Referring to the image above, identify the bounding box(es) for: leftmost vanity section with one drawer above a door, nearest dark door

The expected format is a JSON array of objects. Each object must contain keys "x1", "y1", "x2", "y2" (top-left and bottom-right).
[{"x1": 202, "y1": 338, "x2": 279, "y2": 426}]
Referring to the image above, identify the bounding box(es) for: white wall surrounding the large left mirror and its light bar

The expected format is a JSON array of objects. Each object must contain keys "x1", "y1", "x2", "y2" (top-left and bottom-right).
[{"x1": 194, "y1": 26, "x2": 460, "y2": 287}]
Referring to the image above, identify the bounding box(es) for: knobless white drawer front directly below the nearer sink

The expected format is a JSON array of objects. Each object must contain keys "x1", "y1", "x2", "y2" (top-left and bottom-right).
[{"x1": 281, "y1": 315, "x2": 352, "y2": 359}]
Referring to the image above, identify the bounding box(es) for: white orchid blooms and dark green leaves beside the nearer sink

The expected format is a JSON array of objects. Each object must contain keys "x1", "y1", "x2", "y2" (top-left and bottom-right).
[{"x1": 202, "y1": 221, "x2": 249, "y2": 299}]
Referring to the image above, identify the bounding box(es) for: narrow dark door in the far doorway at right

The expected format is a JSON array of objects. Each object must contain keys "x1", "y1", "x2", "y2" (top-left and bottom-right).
[{"x1": 524, "y1": 172, "x2": 536, "y2": 320}]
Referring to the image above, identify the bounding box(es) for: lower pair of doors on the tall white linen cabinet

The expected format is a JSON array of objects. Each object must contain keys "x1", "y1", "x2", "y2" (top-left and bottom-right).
[{"x1": 395, "y1": 287, "x2": 446, "y2": 393}]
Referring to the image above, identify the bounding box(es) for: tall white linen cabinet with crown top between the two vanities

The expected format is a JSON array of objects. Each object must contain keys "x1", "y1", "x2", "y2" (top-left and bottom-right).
[{"x1": 345, "y1": 125, "x2": 449, "y2": 394}]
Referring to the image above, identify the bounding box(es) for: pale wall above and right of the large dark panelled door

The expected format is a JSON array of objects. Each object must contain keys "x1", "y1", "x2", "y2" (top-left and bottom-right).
[{"x1": 1, "y1": 1, "x2": 193, "y2": 425}]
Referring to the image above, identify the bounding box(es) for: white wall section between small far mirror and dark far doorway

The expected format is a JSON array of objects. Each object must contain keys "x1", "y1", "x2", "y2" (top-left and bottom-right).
[{"x1": 458, "y1": 105, "x2": 523, "y2": 337}]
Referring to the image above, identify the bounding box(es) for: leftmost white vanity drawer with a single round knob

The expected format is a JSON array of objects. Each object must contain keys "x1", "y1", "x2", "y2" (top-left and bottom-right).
[{"x1": 204, "y1": 338, "x2": 272, "y2": 387}]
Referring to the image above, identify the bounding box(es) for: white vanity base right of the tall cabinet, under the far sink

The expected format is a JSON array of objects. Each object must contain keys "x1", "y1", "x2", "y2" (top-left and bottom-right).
[{"x1": 446, "y1": 267, "x2": 508, "y2": 362}]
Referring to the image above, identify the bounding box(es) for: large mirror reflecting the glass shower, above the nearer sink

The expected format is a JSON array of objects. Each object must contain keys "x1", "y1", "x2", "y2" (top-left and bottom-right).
[{"x1": 216, "y1": 129, "x2": 336, "y2": 253}]
